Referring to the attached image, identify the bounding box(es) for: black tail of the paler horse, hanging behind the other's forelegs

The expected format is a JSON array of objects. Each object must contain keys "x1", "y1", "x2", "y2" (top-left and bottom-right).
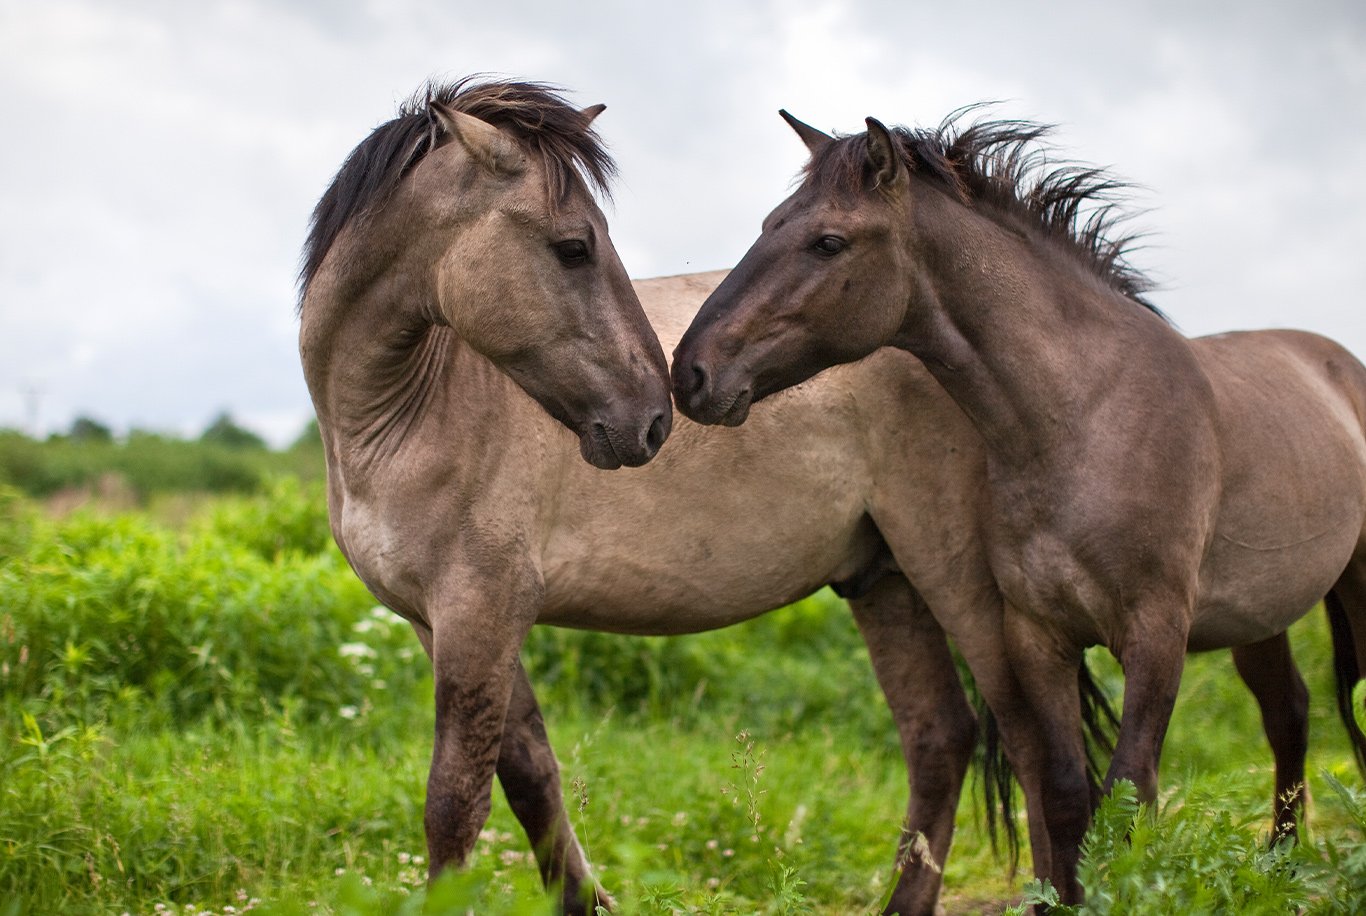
[{"x1": 973, "y1": 644, "x2": 1119, "y2": 874}]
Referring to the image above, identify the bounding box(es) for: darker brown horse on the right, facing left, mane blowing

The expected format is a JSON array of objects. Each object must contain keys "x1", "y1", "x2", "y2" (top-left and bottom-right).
[{"x1": 671, "y1": 109, "x2": 1366, "y2": 902}]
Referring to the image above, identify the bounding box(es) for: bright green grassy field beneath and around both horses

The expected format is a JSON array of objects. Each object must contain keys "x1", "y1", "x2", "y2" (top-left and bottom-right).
[{"x1": 0, "y1": 478, "x2": 1366, "y2": 916}]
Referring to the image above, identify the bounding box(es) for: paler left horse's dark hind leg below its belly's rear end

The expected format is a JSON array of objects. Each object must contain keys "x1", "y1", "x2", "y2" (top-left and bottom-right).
[{"x1": 850, "y1": 576, "x2": 977, "y2": 916}]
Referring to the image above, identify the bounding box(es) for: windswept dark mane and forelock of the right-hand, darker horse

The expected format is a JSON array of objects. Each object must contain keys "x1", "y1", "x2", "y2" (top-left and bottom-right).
[{"x1": 806, "y1": 105, "x2": 1161, "y2": 315}]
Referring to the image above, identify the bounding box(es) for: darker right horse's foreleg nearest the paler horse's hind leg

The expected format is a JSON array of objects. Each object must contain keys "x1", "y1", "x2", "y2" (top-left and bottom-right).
[{"x1": 999, "y1": 607, "x2": 1091, "y2": 904}]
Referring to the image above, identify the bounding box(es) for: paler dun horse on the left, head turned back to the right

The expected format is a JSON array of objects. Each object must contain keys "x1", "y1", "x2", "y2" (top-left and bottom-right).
[{"x1": 299, "y1": 81, "x2": 1023, "y2": 913}]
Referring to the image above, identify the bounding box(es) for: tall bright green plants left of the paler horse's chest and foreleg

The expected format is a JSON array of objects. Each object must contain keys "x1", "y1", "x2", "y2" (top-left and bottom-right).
[{"x1": 0, "y1": 483, "x2": 423, "y2": 722}]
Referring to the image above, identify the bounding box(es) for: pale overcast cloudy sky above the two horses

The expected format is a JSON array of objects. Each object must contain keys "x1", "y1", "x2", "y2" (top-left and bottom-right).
[{"x1": 0, "y1": 0, "x2": 1366, "y2": 442}]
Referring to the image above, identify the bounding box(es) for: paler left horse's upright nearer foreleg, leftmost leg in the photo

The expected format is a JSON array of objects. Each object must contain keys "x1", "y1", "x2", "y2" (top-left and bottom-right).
[{"x1": 423, "y1": 582, "x2": 535, "y2": 879}]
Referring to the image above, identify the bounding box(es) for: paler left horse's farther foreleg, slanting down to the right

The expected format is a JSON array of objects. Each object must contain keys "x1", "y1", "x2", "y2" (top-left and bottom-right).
[{"x1": 497, "y1": 662, "x2": 612, "y2": 916}]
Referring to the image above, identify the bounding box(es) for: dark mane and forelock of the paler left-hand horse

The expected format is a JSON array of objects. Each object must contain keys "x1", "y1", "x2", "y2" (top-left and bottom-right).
[{"x1": 299, "y1": 76, "x2": 616, "y2": 302}]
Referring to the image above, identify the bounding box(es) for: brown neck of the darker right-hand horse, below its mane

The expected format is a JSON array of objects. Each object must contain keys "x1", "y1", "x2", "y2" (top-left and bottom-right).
[{"x1": 896, "y1": 187, "x2": 1184, "y2": 464}]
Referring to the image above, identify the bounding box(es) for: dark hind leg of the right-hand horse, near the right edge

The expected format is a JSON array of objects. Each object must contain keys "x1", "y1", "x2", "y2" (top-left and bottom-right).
[{"x1": 1233, "y1": 633, "x2": 1309, "y2": 840}]
